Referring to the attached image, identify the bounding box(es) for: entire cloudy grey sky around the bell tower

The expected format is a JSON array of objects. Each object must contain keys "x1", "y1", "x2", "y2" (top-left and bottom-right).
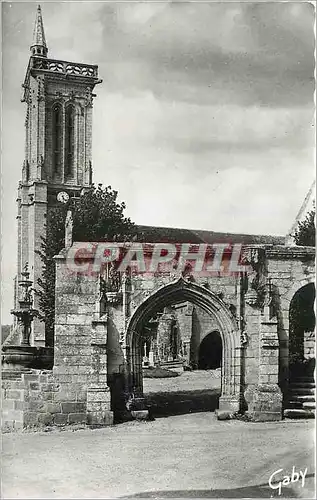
[{"x1": 2, "y1": 1, "x2": 314, "y2": 323}]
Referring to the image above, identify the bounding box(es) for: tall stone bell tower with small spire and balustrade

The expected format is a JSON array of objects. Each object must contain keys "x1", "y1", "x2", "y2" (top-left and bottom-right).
[{"x1": 15, "y1": 6, "x2": 101, "y2": 346}]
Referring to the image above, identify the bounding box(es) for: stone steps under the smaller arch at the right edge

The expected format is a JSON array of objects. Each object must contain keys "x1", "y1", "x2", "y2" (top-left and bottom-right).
[{"x1": 284, "y1": 376, "x2": 316, "y2": 418}]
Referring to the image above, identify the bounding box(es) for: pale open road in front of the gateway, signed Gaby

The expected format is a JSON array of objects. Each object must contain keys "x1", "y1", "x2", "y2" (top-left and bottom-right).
[{"x1": 2, "y1": 413, "x2": 315, "y2": 499}]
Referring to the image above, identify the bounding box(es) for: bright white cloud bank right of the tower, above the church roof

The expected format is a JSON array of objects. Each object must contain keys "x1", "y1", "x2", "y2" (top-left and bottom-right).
[{"x1": 94, "y1": 92, "x2": 314, "y2": 234}]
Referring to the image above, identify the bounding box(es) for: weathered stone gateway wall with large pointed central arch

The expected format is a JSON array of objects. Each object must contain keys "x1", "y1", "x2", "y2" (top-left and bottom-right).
[{"x1": 47, "y1": 238, "x2": 314, "y2": 425}]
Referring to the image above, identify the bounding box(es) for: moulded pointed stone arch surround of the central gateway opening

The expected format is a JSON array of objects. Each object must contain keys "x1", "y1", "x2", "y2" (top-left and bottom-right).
[{"x1": 126, "y1": 278, "x2": 242, "y2": 411}]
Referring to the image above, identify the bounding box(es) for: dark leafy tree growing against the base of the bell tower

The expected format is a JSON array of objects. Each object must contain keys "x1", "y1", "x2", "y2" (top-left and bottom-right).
[{"x1": 36, "y1": 184, "x2": 137, "y2": 347}]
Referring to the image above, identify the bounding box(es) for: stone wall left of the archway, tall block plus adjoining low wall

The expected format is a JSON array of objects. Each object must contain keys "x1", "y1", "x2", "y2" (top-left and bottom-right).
[{"x1": 2, "y1": 255, "x2": 113, "y2": 431}]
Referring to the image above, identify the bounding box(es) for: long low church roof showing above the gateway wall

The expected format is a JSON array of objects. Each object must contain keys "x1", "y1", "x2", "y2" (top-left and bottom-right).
[{"x1": 132, "y1": 225, "x2": 285, "y2": 245}]
